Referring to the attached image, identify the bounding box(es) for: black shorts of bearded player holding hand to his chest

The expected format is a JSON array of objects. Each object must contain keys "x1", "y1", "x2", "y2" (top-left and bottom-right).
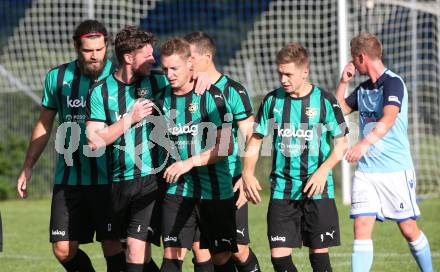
[{"x1": 111, "y1": 175, "x2": 160, "y2": 246}]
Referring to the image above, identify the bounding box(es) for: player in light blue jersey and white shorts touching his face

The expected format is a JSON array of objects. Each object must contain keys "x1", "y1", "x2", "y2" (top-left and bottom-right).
[{"x1": 336, "y1": 33, "x2": 432, "y2": 271}]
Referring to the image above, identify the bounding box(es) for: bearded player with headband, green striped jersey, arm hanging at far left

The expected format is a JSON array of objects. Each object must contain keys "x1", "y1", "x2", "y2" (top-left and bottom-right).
[{"x1": 17, "y1": 20, "x2": 125, "y2": 271}]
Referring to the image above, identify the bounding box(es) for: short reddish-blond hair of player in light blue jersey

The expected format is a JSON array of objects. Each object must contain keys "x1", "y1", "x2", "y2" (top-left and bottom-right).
[{"x1": 350, "y1": 32, "x2": 382, "y2": 59}]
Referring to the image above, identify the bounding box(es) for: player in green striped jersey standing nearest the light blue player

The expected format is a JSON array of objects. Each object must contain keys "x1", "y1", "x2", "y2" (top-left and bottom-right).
[{"x1": 243, "y1": 43, "x2": 348, "y2": 272}]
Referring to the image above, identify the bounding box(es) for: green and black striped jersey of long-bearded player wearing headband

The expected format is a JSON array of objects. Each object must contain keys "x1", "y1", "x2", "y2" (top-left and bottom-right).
[{"x1": 41, "y1": 60, "x2": 114, "y2": 185}]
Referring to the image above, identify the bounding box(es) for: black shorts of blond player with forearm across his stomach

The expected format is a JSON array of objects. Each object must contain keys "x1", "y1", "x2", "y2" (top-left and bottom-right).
[{"x1": 162, "y1": 194, "x2": 238, "y2": 253}]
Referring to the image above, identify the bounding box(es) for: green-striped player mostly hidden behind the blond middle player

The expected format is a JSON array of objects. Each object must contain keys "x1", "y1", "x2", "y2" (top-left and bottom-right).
[{"x1": 185, "y1": 32, "x2": 260, "y2": 272}]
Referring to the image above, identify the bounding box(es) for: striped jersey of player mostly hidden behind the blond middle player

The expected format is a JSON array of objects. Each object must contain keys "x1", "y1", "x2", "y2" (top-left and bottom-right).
[{"x1": 214, "y1": 75, "x2": 253, "y2": 177}]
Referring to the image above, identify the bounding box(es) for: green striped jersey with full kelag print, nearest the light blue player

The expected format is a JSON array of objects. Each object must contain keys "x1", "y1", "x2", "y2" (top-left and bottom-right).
[{"x1": 254, "y1": 86, "x2": 348, "y2": 200}]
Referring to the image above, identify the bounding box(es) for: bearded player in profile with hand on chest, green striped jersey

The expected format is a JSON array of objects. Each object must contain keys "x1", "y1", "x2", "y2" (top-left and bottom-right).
[{"x1": 87, "y1": 26, "x2": 165, "y2": 272}]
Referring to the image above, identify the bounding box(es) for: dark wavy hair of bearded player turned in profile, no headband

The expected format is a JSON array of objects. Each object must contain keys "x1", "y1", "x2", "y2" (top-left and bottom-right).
[{"x1": 115, "y1": 26, "x2": 156, "y2": 64}]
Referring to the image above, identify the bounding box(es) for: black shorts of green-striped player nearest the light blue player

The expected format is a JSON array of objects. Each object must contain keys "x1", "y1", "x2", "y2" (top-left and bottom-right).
[{"x1": 267, "y1": 199, "x2": 341, "y2": 248}]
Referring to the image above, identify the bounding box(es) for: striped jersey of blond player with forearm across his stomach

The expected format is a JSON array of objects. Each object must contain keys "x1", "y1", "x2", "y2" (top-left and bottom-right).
[{"x1": 158, "y1": 86, "x2": 233, "y2": 199}]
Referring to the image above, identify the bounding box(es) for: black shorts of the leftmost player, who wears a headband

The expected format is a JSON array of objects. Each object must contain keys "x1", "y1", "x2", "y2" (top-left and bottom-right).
[{"x1": 49, "y1": 185, "x2": 118, "y2": 244}]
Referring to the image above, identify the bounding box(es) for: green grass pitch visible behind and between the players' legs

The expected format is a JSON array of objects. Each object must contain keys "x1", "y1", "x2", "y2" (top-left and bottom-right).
[{"x1": 0, "y1": 196, "x2": 440, "y2": 272}]
